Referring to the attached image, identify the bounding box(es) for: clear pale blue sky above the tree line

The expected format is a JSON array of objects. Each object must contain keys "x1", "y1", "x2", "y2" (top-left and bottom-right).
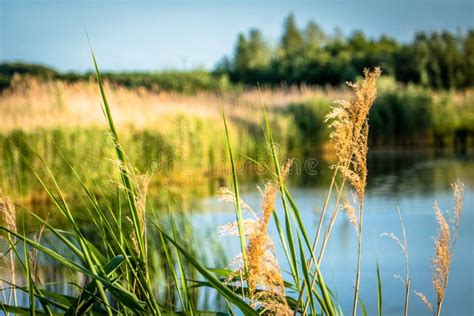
[{"x1": 0, "y1": 0, "x2": 474, "y2": 71}]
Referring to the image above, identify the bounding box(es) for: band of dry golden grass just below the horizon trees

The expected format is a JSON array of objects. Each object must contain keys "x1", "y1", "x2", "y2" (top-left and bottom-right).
[{"x1": 0, "y1": 78, "x2": 349, "y2": 132}]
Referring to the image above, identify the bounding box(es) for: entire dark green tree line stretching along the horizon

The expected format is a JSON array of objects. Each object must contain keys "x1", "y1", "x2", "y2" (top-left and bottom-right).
[{"x1": 0, "y1": 14, "x2": 474, "y2": 93}]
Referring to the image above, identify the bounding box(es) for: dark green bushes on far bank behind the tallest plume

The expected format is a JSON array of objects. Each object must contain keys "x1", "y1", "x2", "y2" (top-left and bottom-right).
[{"x1": 289, "y1": 78, "x2": 474, "y2": 150}]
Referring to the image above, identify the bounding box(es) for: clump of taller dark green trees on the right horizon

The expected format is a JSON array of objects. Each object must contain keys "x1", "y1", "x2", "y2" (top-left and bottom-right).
[{"x1": 215, "y1": 14, "x2": 474, "y2": 89}]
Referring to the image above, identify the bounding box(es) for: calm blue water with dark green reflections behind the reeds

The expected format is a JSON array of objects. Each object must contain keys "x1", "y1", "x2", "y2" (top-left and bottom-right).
[{"x1": 1, "y1": 151, "x2": 474, "y2": 316}]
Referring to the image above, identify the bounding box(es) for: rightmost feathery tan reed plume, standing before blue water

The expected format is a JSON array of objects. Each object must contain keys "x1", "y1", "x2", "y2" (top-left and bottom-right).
[{"x1": 415, "y1": 180, "x2": 464, "y2": 316}]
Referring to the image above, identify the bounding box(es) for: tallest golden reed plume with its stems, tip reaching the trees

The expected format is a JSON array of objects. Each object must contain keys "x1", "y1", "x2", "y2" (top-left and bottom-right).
[{"x1": 297, "y1": 67, "x2": 382, "y2": 315}]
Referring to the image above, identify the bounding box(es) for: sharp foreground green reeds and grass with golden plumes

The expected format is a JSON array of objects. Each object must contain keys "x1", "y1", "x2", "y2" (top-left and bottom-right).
[{"x1": 0, "y1": 58, "x2": 462, "y2": 315}]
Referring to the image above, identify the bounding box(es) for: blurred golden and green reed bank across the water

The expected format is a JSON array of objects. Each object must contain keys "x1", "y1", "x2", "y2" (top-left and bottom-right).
[{"x1": 0, "y1": 77, "x2": 474, "y2": 202}]
